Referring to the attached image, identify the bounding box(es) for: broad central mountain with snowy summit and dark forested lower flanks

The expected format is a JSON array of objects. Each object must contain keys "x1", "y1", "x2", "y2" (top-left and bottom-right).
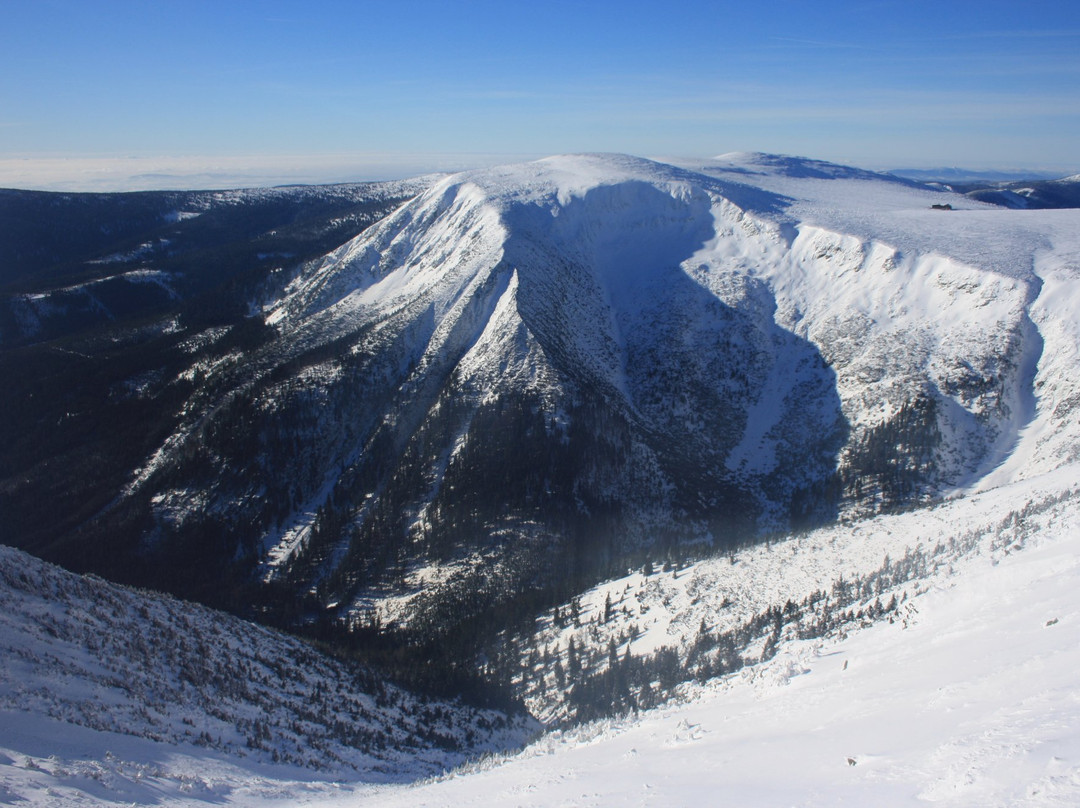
[{"x1": 95, "y1": 156, "x2": 1062, "y2": 639}]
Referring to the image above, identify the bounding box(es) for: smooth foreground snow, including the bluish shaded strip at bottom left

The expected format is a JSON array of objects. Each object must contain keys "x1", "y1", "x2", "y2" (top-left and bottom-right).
[{"x1": 0, "y1": 468, "x2": 1080, "y2": 808}]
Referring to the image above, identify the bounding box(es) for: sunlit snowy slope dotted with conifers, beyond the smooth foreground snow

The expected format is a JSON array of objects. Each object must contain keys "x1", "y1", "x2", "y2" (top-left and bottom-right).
[{"x1": 507, "y1": 466, "x2": 1080, "y2": 725}]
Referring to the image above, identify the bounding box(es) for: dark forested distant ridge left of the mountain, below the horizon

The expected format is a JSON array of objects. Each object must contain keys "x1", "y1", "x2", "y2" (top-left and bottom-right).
[{"x1": 0, "y1": 177, "x2": 435, "y2": 348}]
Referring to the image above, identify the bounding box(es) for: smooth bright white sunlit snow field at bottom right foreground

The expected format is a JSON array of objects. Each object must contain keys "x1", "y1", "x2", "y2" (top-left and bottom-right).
[{"x1": 361, "y1": 466, "x2": 1080, "y2": 806}]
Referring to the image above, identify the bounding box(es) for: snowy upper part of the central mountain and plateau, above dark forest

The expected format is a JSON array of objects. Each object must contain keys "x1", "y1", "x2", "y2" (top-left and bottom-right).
[{"x1": 259, "y1": 154, "x2": 1078, "y2": 583}]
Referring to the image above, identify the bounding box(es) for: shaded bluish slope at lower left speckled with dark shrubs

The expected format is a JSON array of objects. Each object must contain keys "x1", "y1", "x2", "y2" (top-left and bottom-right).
[{"x1": 0, "y1": 547, "x2": 535, "y2": 802}]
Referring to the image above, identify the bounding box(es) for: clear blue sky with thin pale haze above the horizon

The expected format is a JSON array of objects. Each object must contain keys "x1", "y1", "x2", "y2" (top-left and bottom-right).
[{"x1": 0, "y1": 0, "x2": 1080, "y2": 187}]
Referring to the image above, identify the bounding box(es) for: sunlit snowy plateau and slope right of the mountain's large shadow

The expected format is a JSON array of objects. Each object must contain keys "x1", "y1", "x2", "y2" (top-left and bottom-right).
[{"x1": 682, "y1": 153, "x2": 1080, "y2": 485}]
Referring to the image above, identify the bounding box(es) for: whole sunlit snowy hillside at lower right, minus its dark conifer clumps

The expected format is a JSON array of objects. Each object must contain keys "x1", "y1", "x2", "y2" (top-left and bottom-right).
[{"x1": 360, "y1": 467, "x2": 1080, "y2": 807}]
